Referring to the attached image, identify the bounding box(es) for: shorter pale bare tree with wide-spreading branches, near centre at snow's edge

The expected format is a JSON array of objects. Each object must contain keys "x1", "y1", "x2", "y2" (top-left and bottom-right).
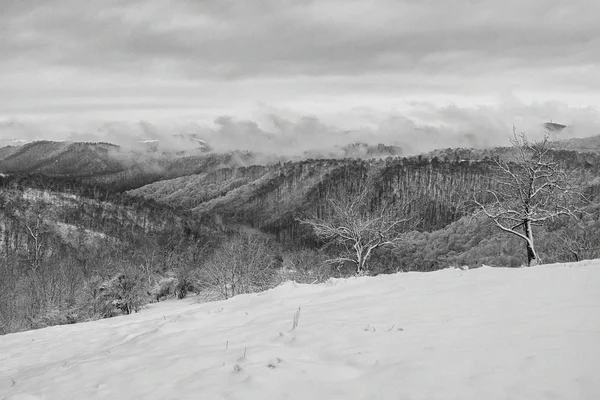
[{"x1": 298, "y1": 185, "x2": 416, "y2": 275}]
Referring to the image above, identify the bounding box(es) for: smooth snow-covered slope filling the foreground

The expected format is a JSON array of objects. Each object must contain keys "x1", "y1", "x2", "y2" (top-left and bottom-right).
[{"x1": 0, "y1": 260, "x2": 600, "y2": 400}]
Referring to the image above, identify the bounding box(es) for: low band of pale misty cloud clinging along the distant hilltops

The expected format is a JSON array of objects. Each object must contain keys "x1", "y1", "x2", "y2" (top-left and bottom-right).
[{"x1": 0, "y1": 96, "x2": 600, "y2": 157}]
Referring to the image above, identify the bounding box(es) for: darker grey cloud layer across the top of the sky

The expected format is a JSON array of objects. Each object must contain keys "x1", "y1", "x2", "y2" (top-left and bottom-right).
[{"x1": 0, "y1": 0, "x2": 600, "y2": 79}]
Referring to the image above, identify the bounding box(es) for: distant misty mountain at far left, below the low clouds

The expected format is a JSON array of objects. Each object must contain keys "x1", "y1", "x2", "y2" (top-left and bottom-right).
[{"x1": 0, "y1": 141, "x2": 256, "y2": 189}]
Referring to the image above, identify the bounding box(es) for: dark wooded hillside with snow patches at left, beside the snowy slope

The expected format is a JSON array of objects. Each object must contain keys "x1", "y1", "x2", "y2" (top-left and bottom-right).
[{"x1": 0, "y1": 175, "x2": 220, "y2": 334}]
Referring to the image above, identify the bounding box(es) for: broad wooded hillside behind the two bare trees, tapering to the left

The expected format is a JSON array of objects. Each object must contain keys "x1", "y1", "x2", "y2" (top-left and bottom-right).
[{"x1": 128, "y1": 142, "x2": 600, "y2": 272}]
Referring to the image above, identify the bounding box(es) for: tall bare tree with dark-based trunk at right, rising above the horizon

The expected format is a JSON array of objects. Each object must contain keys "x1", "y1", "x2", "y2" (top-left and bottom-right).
[{"x1": 474, "y1": 133, "x2": 581, "y2": 266}]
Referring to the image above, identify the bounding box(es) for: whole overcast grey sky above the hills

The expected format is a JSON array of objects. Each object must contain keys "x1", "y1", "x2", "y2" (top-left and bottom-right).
[{"x1": 0, "y1": 0, "x2": 600, "y2": 152}]
